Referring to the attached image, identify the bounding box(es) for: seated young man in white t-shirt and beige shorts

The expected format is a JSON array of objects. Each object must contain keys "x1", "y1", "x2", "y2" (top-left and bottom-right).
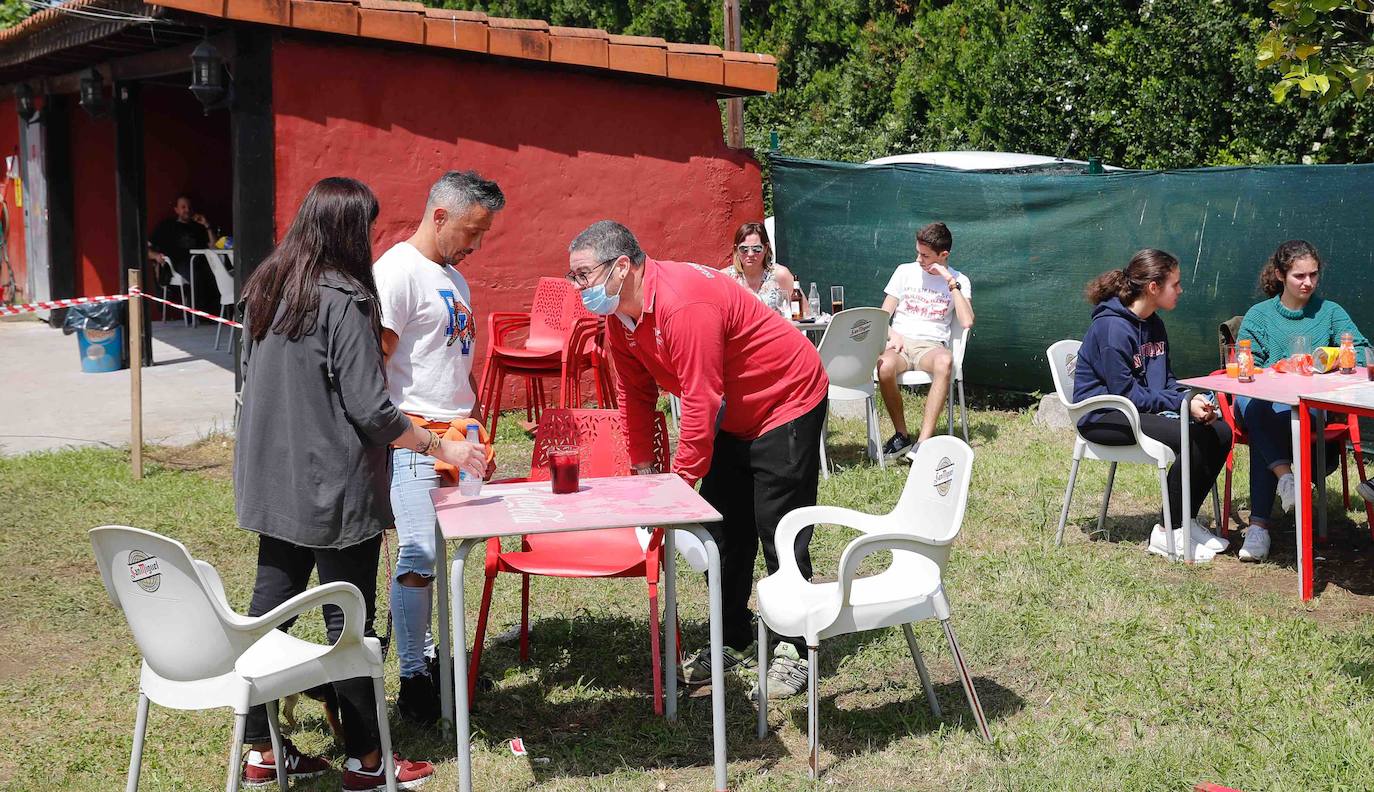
[{"x1": 878, "y1": 223, "x2": 973, "y2": 459}]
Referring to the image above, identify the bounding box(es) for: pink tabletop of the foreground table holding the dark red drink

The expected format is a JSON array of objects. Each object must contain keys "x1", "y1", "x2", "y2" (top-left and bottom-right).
[{"x1": 430, "y1": 473, "x2": 720, "y2": 539}]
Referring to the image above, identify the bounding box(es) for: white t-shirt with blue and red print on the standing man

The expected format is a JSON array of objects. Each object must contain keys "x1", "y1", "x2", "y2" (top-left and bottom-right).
[{"x1": 372, "y1": 242, "x2": 477, "y2": 421}]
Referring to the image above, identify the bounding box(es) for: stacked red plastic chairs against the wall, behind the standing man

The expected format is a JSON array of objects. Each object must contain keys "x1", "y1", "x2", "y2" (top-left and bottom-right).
[{"x1": 480, "y1": 278, "x2": 609, "y2": 437}]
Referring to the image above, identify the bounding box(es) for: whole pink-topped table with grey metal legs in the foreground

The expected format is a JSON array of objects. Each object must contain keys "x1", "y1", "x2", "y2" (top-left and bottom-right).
[{"x1": 430, "y1": 473, "x2": 725, "y2": 792}]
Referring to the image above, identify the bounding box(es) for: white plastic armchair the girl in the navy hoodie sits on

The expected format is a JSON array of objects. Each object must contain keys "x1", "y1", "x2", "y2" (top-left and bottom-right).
[{"x1": 1046, "y1": 340, "x2": 1220, "y2": 558}]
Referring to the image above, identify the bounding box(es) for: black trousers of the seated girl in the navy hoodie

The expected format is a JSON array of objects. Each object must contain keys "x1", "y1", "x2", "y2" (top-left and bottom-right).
[{"x1": 1079, "y1": 410, "x2": 1231, "y2": 521}]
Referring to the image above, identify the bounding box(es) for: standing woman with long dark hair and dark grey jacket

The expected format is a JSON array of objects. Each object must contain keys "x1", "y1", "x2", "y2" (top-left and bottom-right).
[{"x1": 234, "y1": 177, "x2": 485, "y2": 792}]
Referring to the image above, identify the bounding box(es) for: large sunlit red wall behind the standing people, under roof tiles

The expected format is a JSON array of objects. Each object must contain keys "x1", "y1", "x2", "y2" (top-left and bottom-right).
[{"x1": 272, "y1": 39, "x2": 763, "y2": 379}]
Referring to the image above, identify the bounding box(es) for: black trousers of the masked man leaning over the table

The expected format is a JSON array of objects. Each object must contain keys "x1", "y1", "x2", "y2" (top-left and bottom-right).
[{"x1": 701, "y1": 400, "x2": 826, "y2": 656}]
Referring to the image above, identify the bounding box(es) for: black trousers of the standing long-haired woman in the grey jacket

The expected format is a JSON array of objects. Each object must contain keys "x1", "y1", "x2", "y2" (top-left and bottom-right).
[{"x1": 243, "y1": 534, "x2": 382, "y2": 758}]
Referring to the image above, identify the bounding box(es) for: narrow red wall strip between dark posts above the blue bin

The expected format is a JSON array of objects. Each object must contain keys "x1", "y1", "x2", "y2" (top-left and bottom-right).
[{"x1": 67, "y1": 102, "x2": 120, "y2": 297}]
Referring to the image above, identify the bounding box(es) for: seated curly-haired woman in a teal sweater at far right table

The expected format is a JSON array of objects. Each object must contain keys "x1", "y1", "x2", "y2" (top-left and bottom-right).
[{"x1": 1235, "y1": 239, "x2": 1374, "y2": 561}]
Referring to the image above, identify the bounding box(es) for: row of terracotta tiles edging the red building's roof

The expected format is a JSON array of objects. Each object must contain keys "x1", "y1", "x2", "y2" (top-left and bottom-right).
[{"x1": 0, "y1": 0, "x2": 778, "y2": 95}]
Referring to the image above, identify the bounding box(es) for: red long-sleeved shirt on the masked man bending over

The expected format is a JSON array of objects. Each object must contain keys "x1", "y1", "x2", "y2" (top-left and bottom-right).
[{"x1": 606, "y1": 257, "x2": 830, "y2": 483}]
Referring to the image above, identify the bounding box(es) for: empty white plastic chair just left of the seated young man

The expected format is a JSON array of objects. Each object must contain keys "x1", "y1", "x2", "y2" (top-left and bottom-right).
[{"x1": 816, "y1": 308, "x2": 888, "y2": 479}]
